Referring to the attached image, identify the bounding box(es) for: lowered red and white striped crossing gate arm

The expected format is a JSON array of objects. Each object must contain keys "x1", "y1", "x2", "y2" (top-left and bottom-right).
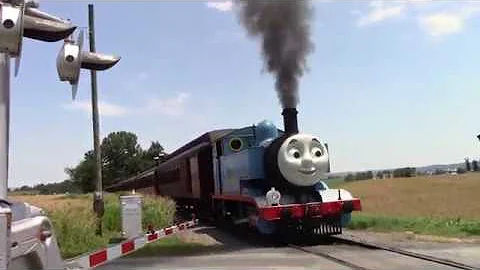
[{"x1": 65, "y1": 220, "x2": 198, "y2": 270}]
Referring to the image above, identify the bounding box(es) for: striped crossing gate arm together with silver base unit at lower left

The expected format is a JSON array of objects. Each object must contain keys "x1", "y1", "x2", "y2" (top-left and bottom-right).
[{"x1": 0, "y1": 197, "x2": 197, "y2": 270}]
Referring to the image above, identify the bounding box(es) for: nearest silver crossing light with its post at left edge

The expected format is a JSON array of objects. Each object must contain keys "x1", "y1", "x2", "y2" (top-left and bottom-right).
[{"x1": 0, "y1": 1, "x2": 76, "y2": 200}]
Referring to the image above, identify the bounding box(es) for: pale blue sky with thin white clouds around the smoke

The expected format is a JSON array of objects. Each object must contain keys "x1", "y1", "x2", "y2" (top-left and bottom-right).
[{"x1": 9, "y1": 0, "x2": 480, "y2": 187}]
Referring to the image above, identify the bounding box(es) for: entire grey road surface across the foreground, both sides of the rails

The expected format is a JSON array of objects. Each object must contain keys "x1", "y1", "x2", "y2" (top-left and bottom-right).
[{"x1": 97, "y1": 228, "x2": 480, "y2": 270}]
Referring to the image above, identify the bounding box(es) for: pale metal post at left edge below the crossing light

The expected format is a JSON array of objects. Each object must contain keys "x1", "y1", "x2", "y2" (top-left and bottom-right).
[{"x1": 0, "y1": 53, "x2": 10, "y2": 200}]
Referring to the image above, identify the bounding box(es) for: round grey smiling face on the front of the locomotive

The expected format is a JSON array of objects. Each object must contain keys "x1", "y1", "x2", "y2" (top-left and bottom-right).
[{"x1": 277, "y1": 134, "x2": 328, "y2": 186}]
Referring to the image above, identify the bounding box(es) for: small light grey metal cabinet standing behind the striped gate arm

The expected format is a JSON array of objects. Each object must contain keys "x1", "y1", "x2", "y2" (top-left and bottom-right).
[{"x1": 120, "y1": 195, "x2": 142, "y2": 239}]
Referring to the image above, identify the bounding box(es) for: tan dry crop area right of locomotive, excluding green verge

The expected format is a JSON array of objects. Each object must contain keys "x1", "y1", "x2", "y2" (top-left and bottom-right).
[{"x1": 341, "y1": 173, "x2": 480, "y2": 220}]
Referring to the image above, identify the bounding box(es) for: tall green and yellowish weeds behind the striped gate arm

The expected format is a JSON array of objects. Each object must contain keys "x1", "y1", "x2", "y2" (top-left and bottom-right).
[{"x1": 44, "y1": 194, "x2": 175, "y2": 258}]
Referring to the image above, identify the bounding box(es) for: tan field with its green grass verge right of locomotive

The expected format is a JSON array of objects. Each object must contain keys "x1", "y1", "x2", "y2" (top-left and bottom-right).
[{"x1": 338, "y1": 173, "x2": 480, "y2": 236}]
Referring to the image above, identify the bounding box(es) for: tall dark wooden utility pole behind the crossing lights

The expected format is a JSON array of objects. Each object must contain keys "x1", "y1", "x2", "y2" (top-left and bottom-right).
[{"x1": 88, "y1": 4, "x2": 104, "y2": 235}]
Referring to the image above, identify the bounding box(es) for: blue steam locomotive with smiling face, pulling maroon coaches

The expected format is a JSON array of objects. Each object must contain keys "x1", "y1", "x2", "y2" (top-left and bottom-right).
[{"x1": 106, "y1": 108, "x2": 361, "y2": 235}]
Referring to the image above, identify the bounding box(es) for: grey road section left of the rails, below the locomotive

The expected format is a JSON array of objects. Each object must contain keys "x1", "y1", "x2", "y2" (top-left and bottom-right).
[{"x1": 97, "y1": 228, "x2": 349, "y2": 270}]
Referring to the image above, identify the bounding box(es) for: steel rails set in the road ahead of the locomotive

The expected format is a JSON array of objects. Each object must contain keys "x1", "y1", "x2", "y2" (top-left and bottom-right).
[{"x1": 288, "y1": 236, "x2": 480, "y2": 270}]
